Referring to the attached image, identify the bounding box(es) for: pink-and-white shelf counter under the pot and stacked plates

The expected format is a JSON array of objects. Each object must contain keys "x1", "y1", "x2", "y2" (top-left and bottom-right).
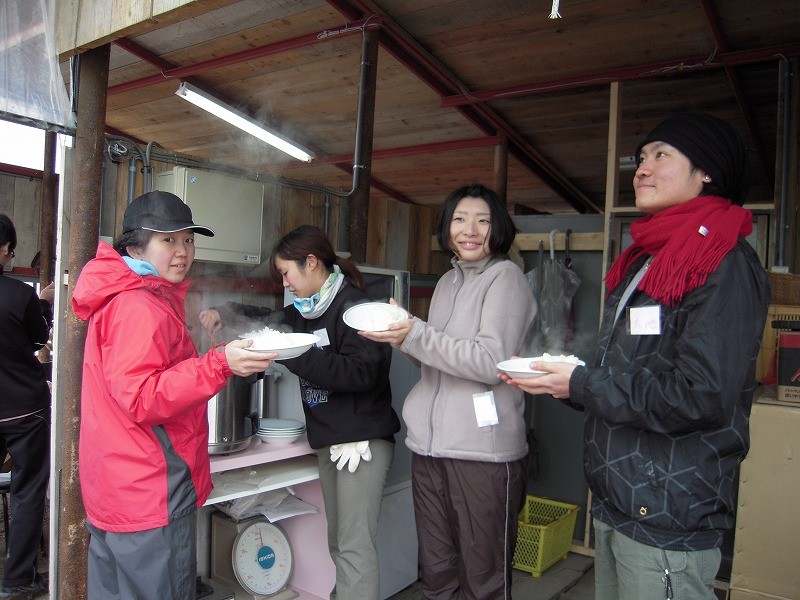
[{"x1": 203, "y1": 438, "x2": 336, "y2": 600}]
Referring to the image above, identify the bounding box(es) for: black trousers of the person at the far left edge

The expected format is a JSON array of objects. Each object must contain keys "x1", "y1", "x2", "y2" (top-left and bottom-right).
[{"x1": 0, "y1": 410, "x2": 50, "y2": 588}]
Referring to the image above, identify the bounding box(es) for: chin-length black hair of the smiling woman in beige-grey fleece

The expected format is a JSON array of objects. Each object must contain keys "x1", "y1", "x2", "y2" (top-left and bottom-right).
[{"x1": 436, "y1": 183, "x2": 517, "y2": 256}]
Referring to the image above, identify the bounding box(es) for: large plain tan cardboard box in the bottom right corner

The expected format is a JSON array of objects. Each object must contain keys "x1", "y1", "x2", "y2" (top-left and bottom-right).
[{"x1": 730, "y1": 402, "x2": 800, "y2": 600}]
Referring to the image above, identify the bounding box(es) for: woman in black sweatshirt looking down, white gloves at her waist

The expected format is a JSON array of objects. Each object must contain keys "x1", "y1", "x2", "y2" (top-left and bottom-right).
[{"x1": 200, "y1": 225, "x2": 400, "y2": 600}]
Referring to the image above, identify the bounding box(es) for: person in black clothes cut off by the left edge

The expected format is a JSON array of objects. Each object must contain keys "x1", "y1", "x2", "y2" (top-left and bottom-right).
[{"x1": 0, "y1": 214, "x2": 55, "y2": 598}]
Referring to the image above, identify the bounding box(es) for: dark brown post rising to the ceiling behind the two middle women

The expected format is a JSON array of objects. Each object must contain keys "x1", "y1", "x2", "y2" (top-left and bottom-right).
[{"x1": 349, "y1": 29, "x2": 380, "y2": 262}]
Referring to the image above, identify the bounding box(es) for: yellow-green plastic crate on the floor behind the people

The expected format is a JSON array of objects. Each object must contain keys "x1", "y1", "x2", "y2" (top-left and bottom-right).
[{"x1": 514, "y1": 495, "x2": 580, "y2": 577}]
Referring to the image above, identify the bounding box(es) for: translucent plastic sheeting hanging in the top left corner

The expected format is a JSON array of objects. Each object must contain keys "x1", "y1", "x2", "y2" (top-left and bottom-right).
[{"x1": 0, "y1": 0, "x2": 75, "y2": 130}]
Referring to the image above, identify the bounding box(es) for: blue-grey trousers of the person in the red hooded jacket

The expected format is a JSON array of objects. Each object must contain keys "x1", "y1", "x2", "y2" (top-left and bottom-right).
[{"x1": 86, "y1": 511, "x2": 197, "y2": 600}]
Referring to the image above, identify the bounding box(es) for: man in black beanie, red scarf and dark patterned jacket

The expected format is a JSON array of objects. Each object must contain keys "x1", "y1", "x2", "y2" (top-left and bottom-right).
[{"x1": 501, "y1": 113, "x2": 770, "y2": 600}]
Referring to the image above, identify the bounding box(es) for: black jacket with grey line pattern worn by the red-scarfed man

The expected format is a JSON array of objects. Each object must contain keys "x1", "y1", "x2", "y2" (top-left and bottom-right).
[{"x1": 570, "y1": 239, "x2": 770, "y2": 551}]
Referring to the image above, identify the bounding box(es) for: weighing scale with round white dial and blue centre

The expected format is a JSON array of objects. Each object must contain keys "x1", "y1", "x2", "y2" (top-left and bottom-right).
[{"x1": 211, "y1": 512, "x2": 298, "y2": 600}]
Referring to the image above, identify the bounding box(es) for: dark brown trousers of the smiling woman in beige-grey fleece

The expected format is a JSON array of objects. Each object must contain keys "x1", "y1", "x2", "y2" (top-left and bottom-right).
[{"x1": 411, "y1": 454, "x2": 526, "y2": 600}]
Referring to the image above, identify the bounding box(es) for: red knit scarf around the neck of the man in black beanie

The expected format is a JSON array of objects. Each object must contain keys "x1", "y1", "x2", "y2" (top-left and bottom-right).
[{"x1": 606, "y1": 196, "x2": 753, "y2": 306}]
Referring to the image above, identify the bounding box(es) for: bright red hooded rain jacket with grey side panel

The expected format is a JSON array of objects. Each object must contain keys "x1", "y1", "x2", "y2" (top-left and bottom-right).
[{"x1": 72, "y1": 242, "x2": 233, "y2": 532}]
